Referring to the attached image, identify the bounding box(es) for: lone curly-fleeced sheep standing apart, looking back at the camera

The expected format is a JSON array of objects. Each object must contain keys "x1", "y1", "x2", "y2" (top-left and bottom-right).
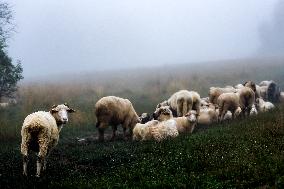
[{"x1": 21, "y1": 103, "x2": 75, "y2": 177}]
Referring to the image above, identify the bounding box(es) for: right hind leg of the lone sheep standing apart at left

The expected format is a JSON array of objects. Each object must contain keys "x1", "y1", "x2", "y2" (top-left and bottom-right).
[{"x1": 36, "y1": 134, "x2": 48, "y2": 177}]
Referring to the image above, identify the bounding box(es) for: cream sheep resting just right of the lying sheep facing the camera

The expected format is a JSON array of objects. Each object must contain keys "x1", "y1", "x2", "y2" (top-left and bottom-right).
[{"x1": 197, "y1": 103, "x2": 218, "y2": 125}]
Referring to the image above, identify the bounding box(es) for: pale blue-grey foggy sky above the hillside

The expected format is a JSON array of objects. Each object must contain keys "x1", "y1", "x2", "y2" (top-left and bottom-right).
[{"x1": 8, "y1": 0, "x2": 277, "y2": 77}]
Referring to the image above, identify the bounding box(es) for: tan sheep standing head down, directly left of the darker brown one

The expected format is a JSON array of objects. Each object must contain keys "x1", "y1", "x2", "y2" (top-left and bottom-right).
[{"x1": 217, "y1": 93, "x2": 242, "y2": 121}]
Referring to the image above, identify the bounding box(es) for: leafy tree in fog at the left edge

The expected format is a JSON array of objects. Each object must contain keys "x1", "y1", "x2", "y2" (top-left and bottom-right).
[{"x1": 0, "y1": 1, "x2": 23, "y2": 102}]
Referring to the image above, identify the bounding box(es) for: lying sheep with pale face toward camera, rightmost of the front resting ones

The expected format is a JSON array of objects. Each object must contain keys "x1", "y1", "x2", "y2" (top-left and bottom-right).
[{"x1": 173, "y1": 110, "x2": 197, "y2": 134}]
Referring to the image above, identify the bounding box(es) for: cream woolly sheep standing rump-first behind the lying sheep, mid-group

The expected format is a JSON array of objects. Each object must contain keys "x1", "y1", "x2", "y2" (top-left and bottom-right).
[{"x1": 157, "y1": 90, "x2": 201, "y2": 117}]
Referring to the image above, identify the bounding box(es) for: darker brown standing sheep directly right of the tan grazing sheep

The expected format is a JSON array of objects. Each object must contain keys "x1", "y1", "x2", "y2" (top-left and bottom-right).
[{"x1": 237, "y1": 87, "x2": 255, "y2": 116}]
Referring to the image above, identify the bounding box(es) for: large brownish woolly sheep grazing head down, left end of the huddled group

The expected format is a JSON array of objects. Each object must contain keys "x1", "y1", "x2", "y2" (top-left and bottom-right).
[{"x1": 95, "y1": 96, "x2": 140, "y2": 141}]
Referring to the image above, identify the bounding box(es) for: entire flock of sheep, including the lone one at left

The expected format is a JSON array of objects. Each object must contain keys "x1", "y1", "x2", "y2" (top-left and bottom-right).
[{"x1": 18, "y1": 81, "x2": 284, "y2": 177}]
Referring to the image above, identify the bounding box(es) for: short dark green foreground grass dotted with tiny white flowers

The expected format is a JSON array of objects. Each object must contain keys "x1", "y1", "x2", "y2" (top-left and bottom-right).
[{"x1": 0, "y1": 106, "x2": 284, "y2": 188}]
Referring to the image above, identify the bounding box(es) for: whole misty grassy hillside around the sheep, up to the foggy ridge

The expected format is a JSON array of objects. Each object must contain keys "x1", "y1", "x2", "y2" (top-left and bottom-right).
[{"x1": 0, "y1": 59, "x2": 284, "y2": 188}]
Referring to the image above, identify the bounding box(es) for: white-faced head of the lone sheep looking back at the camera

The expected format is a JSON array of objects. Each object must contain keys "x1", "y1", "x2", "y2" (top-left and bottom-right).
[{"x1": 50, "y1": 103, "x2": 75, "y2": 124}]
